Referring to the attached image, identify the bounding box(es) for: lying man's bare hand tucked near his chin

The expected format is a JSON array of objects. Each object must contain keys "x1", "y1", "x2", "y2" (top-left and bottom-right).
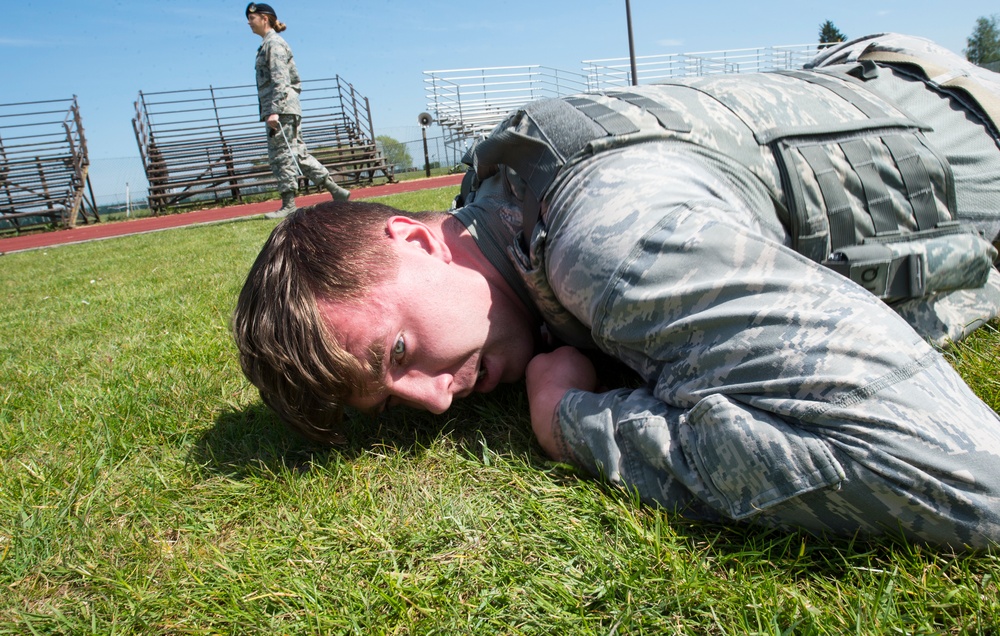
[{"x1": 525, "y1": 347, "x2": 597, "y2": 461}]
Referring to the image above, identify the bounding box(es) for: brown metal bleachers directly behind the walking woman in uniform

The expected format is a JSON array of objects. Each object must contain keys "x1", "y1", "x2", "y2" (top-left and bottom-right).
[{"x1": 132, "y1": 76, "x2": 395, "y2": 214}]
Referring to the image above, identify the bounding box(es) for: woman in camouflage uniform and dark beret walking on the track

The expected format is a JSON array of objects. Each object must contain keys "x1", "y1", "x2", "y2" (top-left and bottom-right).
[{"x1": 246, "y1": 2, "x2": 351, "y2": 219}]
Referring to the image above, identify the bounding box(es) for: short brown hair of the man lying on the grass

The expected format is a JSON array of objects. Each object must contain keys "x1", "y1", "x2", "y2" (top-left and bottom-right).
[{"x1": 232, "y1": 201, "x2": 446, "y2": 442}]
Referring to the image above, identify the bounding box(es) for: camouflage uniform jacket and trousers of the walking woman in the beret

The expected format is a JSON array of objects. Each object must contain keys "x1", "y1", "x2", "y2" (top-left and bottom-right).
[{"x1": 255, "y1": 31, "x2": 330, "y2": 192}]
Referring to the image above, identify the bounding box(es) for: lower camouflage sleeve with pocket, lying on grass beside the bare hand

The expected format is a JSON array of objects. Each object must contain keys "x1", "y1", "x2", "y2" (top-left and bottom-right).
[{"x1": 559, "y1": 389, "x2": 845, "y2": 519}]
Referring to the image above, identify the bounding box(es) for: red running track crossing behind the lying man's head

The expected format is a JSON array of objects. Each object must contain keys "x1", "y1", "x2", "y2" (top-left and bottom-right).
[{"x1": 0, "y1": 174, "x2": 464, "y2": 255}]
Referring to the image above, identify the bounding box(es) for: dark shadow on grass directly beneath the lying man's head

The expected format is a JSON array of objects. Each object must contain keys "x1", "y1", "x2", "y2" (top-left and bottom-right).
[{"x1": 188, "y1": 384, "x2": 545, "y2": 479}]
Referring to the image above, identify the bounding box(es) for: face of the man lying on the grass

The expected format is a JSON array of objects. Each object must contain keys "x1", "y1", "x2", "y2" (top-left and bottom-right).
[{"x1": 320, "y1": 219, "x2": 538, "y2": 413}]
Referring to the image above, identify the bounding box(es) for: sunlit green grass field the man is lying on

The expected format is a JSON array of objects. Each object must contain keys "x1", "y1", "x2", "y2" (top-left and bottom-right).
[{"x1": 0, "y1": 188, "x2": 1000, "y2": 634}]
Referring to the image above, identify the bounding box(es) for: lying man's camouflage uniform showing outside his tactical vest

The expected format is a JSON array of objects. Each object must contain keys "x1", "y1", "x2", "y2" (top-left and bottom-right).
[{"x1": 456, "y1": 33, "x2": 1000, "y2": 547}]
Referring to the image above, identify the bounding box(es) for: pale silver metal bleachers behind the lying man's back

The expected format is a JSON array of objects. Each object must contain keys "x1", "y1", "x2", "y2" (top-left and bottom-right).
[{"x1": 424, "y1": 44, "x2": 818, "y2": 156}]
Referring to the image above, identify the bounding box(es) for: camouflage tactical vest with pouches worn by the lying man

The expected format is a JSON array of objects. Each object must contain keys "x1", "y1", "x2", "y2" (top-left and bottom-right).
[{"x1": 459, "y1": 63, "x2": 997, "y2": 300}]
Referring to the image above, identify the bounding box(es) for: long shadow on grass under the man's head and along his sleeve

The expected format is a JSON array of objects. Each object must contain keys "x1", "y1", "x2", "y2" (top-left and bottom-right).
[{"x1": 189, "y1": 384, "x2": 921, "y2": 556}]
